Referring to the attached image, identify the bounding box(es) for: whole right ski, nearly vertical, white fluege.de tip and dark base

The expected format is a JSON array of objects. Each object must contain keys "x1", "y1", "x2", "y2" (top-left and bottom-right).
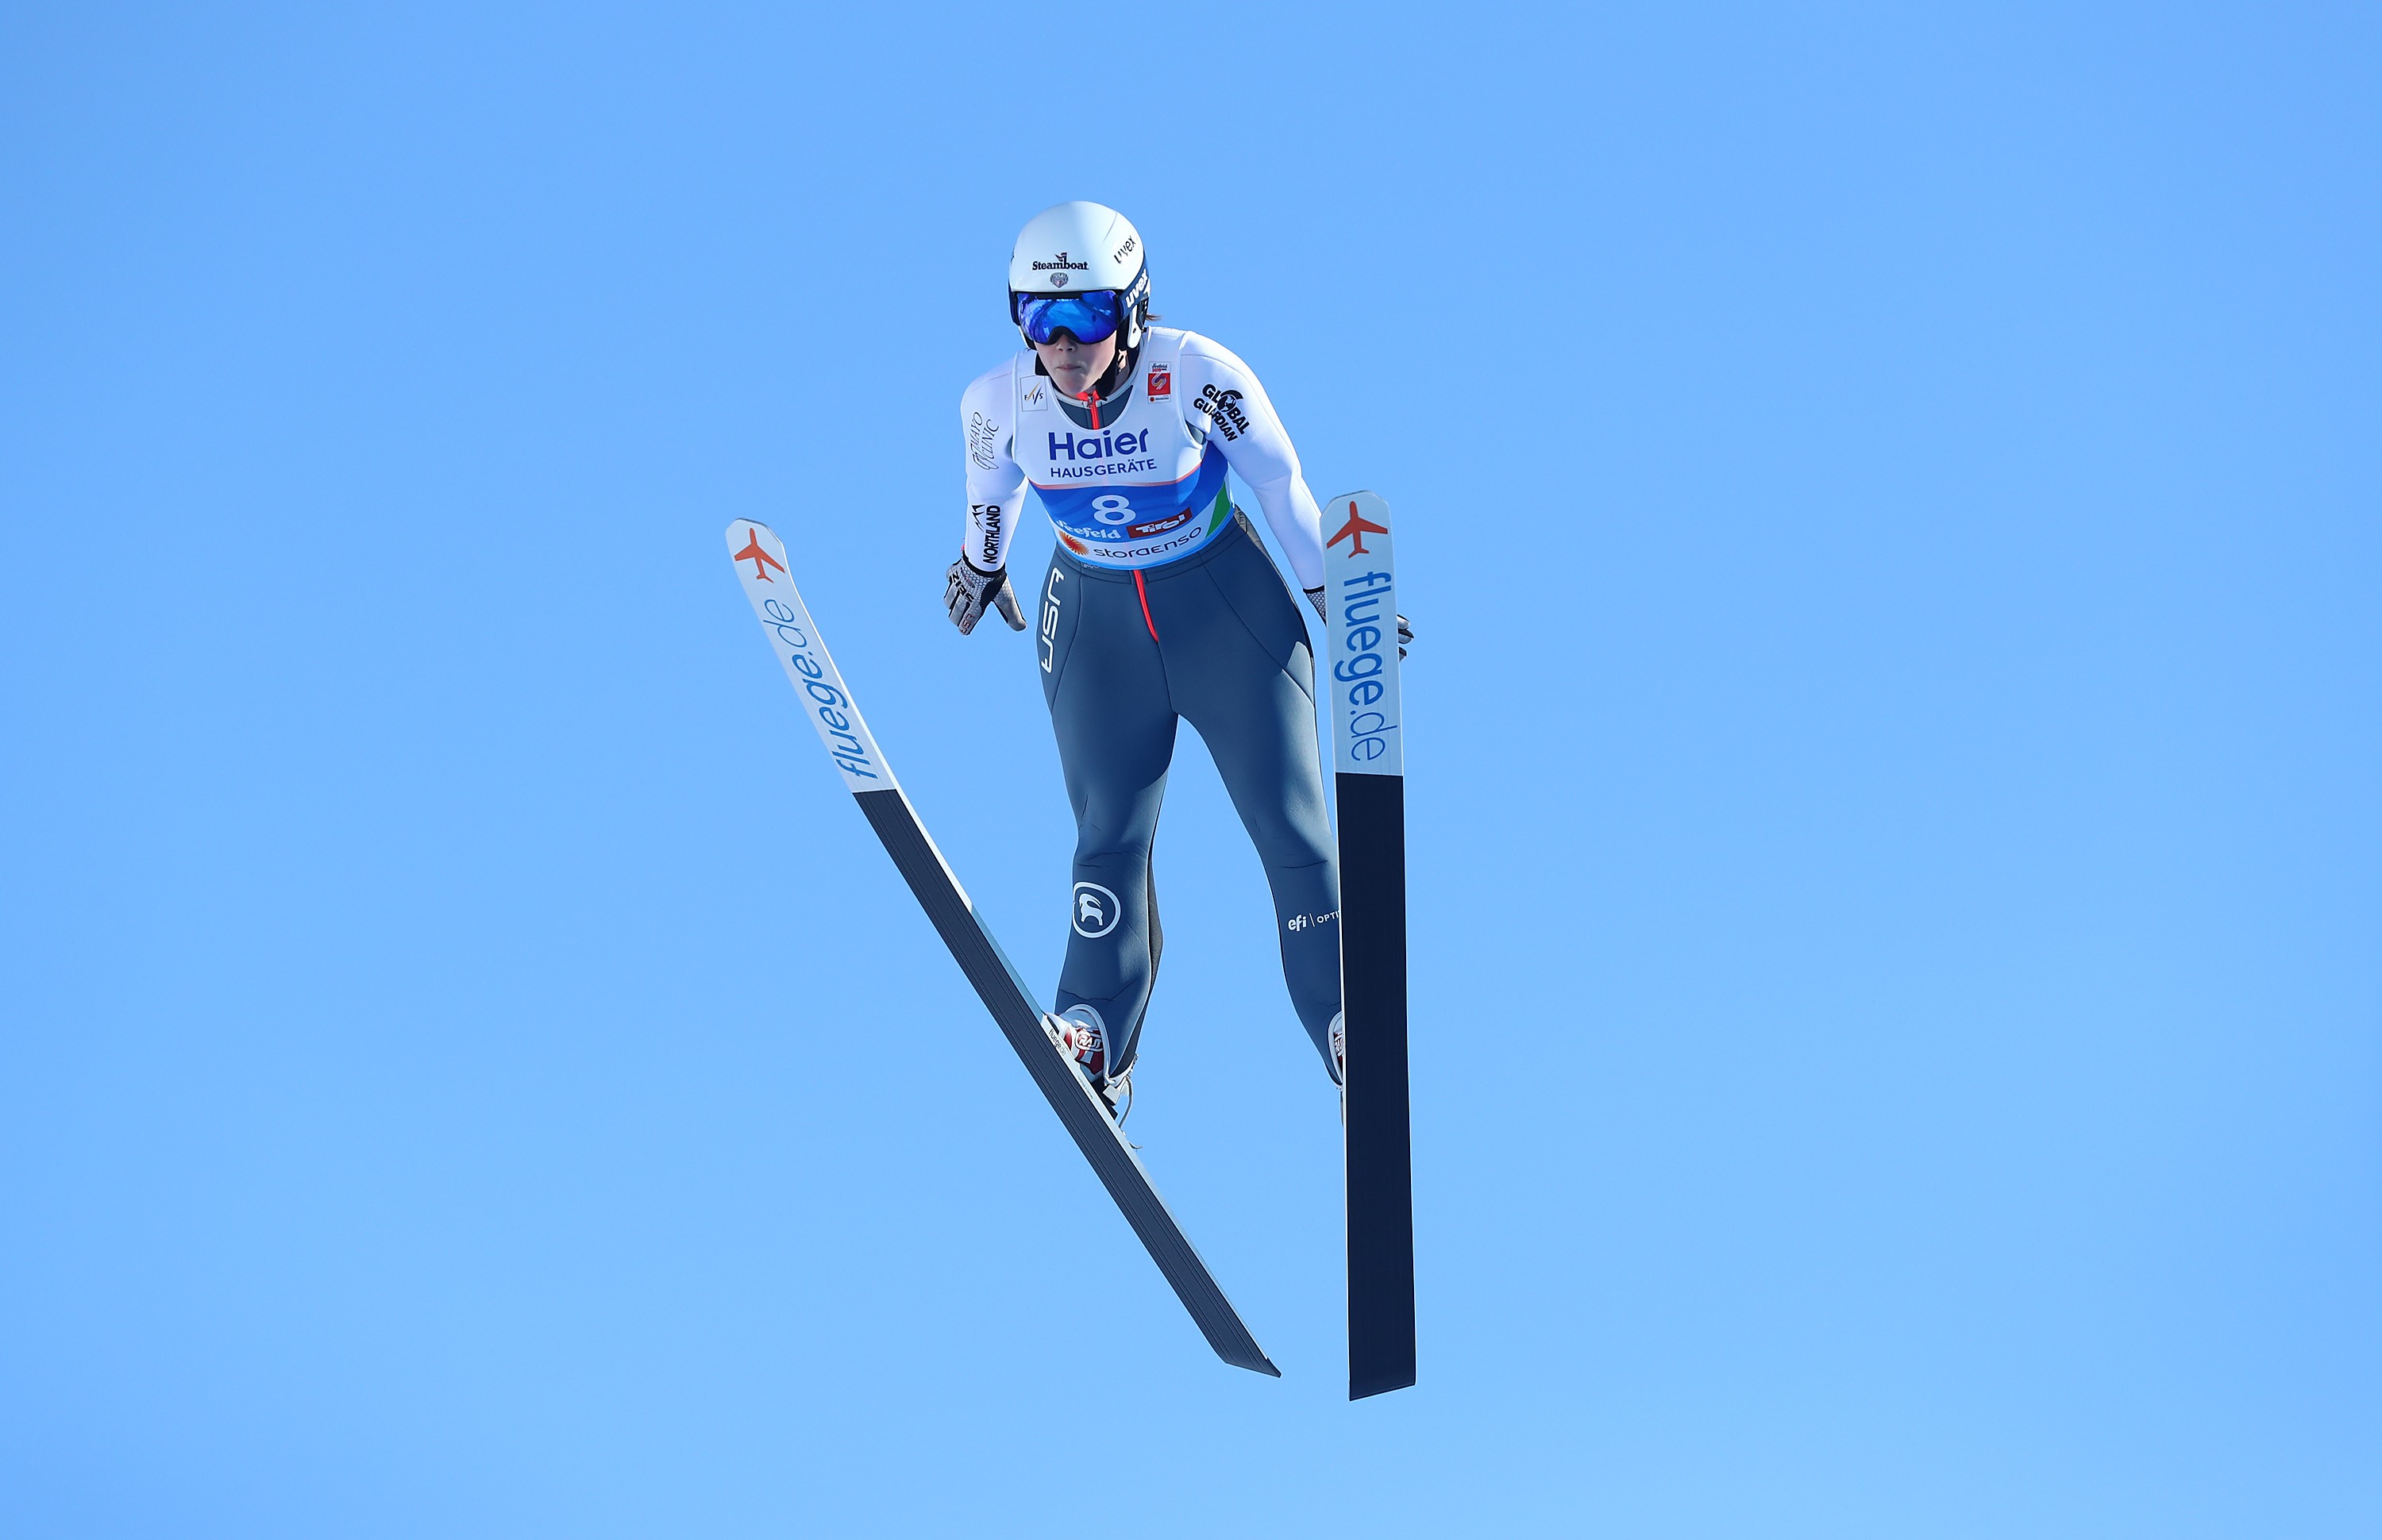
[{"x1": 1324, "y1": 493, "x2": 1415, "y2": 1399}]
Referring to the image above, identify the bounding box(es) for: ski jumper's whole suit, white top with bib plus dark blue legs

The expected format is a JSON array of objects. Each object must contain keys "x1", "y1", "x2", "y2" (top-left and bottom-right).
[{"x1": 960, "y1": 326, "x2": 1341, "y2": 1076}]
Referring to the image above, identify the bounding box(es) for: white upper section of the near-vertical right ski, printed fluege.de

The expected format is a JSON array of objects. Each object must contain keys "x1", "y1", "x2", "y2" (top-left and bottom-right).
[{"x1": 1324, "y1": 493, "x2": 1405, "y2": 776}]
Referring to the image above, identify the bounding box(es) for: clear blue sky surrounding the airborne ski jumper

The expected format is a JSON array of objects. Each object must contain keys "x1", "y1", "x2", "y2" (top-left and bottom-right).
[{"x1": 0, "y1": 5, "x2": 2382, "y2": 1540}]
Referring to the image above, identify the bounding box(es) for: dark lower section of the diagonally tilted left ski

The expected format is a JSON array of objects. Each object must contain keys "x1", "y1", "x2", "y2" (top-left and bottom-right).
[{"x1": 853, "y1": 787, "x2": 1282, "y2": 1378}]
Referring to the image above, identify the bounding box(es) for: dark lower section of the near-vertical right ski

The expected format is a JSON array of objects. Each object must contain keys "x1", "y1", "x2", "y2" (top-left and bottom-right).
[{"x1": 1334, "y1": 773, "x2": 1415, "y2": 1399}]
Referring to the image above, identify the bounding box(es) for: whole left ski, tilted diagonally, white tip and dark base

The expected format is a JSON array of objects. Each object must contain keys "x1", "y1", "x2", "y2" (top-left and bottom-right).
[{"x1": 729, "y1": 519, "x2": 1282, "y2": 1378}]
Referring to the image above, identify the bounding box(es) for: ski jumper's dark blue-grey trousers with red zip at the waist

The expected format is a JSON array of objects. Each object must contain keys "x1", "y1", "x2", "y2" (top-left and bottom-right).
[{"x1": 1036, "y1": 514, "x2": 1341, "y2": 1068}]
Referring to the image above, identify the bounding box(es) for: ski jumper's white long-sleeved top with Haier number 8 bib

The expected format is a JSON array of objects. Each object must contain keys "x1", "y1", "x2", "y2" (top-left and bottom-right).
[{"x1": 960, "y1": 326, "x2": 1324, "y2": 588}]
